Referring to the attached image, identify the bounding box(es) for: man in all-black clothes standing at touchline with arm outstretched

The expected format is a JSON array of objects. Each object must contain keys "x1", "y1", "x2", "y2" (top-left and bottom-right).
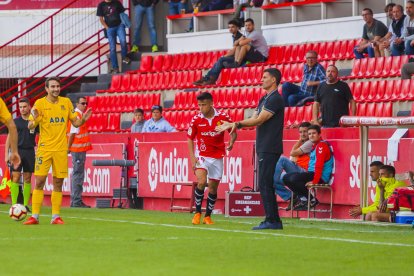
[{"x1": 216, "y1": 68, "x2": 285, "y2": 230}]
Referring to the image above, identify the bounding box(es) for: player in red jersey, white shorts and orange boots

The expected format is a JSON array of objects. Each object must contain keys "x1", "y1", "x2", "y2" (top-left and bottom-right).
[{"x1": 187, "y1": 92, "x2": 237, "y2": 224}]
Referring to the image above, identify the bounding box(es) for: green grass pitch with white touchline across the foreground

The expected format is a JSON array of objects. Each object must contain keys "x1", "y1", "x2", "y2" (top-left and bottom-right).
[{"x1": 0, "y1": 205, "x2": 414, "y2": 275}]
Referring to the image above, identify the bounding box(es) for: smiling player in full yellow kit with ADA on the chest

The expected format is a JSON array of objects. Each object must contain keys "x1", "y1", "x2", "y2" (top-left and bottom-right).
[{"x1": 24, "y1": 77, "x2": 92, "y2": 225}]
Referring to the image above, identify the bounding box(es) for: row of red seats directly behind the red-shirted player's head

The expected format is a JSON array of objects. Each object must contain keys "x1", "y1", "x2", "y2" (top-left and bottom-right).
[{"x1": 171, "y1": 87, "x2": 265, "y2": 110}]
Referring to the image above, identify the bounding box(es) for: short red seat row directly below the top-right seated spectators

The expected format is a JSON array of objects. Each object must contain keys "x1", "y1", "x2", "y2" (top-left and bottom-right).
[{"x1": 348, "y1": 56, "x2": 409, "y2": 79}]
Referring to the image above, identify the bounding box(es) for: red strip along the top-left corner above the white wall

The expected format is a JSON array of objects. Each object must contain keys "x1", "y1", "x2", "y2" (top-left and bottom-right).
[{"x1": 0, "y1": 0, "x2": 101, "y2": 10}]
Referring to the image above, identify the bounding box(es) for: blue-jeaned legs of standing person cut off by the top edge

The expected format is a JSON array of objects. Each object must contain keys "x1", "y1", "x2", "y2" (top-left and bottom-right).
[{"x1": 131, "y1": 0, "x2": 158, "y2": 53}]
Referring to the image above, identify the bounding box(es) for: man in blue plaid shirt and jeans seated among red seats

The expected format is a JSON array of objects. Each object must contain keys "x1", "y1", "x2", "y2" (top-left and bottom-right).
[{"x1": 282, "y1": 50, "x2": 325, "y2": 106}]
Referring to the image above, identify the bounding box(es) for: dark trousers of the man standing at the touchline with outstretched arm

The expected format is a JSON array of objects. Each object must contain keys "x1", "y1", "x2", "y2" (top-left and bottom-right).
[{"x1": 257, "y1": 152, "x2": 280, "y2": 223}]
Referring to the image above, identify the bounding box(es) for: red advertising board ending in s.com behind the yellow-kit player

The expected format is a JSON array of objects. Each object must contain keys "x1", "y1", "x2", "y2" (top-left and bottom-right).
[{"x1": 0, "y1": 144, "x2": 125, "y2": 197}]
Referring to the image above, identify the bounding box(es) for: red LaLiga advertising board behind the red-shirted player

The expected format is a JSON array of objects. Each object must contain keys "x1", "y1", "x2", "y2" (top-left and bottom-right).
[{"x1": 138, "y1": 141, "x2": 254, "y2": 199}]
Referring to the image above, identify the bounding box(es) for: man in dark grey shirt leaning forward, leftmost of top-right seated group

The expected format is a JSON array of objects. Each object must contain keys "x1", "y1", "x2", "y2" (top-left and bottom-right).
[{"x1": 354, "y1": 8, "x2": 388, "y2": 59}]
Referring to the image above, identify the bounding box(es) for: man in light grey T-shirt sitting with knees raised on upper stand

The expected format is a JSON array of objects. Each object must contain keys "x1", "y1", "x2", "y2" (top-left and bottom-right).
[{"x1": 224, "y1": 18, "x2": 269, "y2": 68}]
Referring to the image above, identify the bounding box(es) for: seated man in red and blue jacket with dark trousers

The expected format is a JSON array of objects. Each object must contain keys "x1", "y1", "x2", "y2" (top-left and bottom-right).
[{"x1": 283, "y1": 125, "x2": 334, "y2": 211}]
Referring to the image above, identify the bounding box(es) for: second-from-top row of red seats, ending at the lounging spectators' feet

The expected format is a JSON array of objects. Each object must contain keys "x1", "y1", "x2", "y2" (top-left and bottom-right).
[{"x1": 96, "y1": 70, "x2": 202, "y2": 94}]
